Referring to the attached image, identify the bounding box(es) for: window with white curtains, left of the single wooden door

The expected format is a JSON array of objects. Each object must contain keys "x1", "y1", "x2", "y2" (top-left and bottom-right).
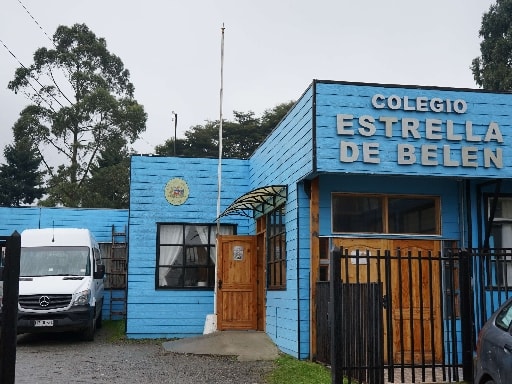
[{"x1": 156, "y1": 223, "x2": 235, "y2": 289}]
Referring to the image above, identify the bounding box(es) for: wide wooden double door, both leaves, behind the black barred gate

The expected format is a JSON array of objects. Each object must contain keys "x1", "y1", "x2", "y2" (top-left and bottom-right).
[{"x1": 333, "y1": 238, "x2": 442, "y2": 363}]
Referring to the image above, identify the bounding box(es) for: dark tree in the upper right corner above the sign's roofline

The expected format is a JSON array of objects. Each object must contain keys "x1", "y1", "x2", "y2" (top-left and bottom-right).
[{"x1": 471, "y1": 0, "x2": 512, "y2": 91}]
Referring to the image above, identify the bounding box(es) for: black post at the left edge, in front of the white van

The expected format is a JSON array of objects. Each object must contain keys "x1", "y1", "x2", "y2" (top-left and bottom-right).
[{"x1": 0, "y1": 231, "x2": 21, "y2": 384}]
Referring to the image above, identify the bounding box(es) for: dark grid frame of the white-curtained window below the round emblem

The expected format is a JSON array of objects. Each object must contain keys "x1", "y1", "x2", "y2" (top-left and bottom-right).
[{"x1": 155, "y1": 222, "x2": 237, "y2": 291}]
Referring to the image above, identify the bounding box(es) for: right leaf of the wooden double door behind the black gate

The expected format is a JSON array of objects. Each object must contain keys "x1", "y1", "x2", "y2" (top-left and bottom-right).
[{"x1": 391, "y1": 240, "x2": 442, "y2": 364}]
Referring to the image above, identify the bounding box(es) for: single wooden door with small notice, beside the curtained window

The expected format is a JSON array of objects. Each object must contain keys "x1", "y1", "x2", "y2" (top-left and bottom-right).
[{"x1": 217, "y1": 236, "x2": 258, "y2": 331}]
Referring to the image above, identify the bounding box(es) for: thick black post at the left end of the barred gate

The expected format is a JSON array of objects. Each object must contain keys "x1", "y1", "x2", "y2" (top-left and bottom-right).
[{"x1": 329, "y1": 248, "x2": 343, "y2": 384}]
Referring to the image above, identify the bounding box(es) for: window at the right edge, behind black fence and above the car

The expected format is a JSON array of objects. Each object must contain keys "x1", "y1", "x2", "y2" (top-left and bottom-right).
[{"x1": 487, "y1": 197, "x2": 512, "y2": 288}]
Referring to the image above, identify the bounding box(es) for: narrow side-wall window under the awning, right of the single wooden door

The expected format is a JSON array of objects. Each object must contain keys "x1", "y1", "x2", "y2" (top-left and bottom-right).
[{"x1": 267, "y1": 205, "x2": 286, "y2": 290}]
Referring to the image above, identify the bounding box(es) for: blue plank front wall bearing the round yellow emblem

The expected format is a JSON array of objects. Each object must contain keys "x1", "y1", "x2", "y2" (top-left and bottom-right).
[{"x1": 127, "y1": 156, "x2": 249, "y2": 338}]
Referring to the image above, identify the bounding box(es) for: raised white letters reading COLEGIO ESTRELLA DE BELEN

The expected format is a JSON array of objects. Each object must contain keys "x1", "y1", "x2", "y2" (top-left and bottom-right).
[{"x1": 336, "y1": 94, "x2": 504, "y2": 169}]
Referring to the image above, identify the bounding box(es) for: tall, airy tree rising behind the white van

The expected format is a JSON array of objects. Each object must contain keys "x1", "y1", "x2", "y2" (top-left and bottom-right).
[{"x1": 8, "y1": 24, "x2": 147, "y2": 207}]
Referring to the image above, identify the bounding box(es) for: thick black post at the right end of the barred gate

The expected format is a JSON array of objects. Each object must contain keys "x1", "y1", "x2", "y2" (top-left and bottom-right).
[{"x1": 459, "y1": 250, "x2": 475, "y2": 383}]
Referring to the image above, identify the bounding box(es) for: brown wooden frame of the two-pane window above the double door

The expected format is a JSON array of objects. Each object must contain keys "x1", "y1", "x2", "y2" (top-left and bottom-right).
[{"x1": 331, "y1": 192, "x2": 441, "y2": 237}]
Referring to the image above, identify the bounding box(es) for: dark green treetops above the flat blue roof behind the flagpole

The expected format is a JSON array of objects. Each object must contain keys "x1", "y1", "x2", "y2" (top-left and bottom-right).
[{"x1": 155, "y1": 101, "x2": 293, "y2": 159}]
